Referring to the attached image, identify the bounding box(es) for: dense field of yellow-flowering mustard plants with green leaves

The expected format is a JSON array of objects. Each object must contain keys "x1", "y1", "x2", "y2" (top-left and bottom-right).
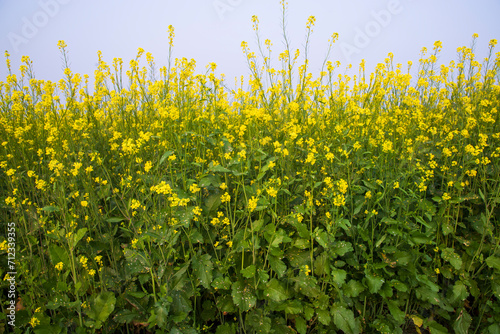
[{"x1": 0, "y1": 9, "x2": 500, "y2": 334}]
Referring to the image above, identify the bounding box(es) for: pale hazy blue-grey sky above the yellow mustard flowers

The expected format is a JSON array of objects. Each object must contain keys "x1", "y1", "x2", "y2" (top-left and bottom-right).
[{"x1": 0, "y1": 0, "x2": 500, "y2": 87}]
